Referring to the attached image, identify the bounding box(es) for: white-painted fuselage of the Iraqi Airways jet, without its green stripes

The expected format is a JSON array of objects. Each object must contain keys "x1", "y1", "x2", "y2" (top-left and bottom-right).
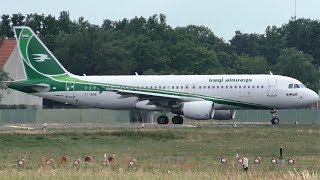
[{"x1": 36, "y1": 75, "x2": 318, "y2": 110}]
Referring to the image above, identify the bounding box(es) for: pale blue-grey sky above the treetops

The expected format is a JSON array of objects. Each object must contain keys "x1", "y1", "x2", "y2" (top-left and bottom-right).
[{"x1": 0, "y1": 0, "x2": 320, "y2": 41}]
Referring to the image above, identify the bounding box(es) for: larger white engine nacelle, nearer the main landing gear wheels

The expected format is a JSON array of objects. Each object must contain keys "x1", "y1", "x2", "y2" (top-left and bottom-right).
[{"x1": 181, "y1": 101, "x2": 214, "y2": 120}]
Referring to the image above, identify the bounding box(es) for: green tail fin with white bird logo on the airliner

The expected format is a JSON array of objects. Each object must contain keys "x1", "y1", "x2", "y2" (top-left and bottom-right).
[{"x1": 14, "y1": 27, "x2": 70, "y2": 79}]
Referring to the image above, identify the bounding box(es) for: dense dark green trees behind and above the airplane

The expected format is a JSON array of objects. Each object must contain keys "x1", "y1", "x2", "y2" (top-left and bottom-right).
[{"x1": 0, "y1": 11, "x2": 320, "y2": 90}]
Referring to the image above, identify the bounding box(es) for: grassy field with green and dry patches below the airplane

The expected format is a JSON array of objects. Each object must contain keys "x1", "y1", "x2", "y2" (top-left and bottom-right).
[{"x1": 0, "y1": 125, "x2": 320, "y2": 179}]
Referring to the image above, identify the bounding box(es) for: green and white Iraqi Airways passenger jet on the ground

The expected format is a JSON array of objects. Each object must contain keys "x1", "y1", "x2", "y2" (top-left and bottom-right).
[{"x1": 6, "y1": 26, "x2": 319, "y2": 124}]
